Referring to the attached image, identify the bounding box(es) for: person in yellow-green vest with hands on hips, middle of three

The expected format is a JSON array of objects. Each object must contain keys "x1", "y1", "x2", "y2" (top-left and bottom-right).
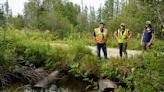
[{"x1": 114, "y1": 23, "x2": 132, "y2": 57}]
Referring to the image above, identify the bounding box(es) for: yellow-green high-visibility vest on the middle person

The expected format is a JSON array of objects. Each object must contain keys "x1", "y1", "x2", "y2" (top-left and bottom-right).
[{"x1": 118, "y1": 29, "x2": 129, "y2": 43}]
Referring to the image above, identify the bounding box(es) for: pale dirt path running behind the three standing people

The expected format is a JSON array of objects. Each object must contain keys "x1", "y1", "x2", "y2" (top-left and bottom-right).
[{"x1": 51, "y1": 43, "x2": 142, "y2": 57}]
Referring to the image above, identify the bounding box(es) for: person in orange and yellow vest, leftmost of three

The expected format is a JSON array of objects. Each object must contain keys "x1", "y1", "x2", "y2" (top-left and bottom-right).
[{"x1": 93, "y1": 22, "x2": 108, "y2": 59}]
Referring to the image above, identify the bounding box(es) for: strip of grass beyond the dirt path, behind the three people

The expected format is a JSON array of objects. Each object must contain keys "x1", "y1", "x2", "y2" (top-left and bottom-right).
[{"x1": 53, "y1": 34, "x2": 163, "y2": 50}]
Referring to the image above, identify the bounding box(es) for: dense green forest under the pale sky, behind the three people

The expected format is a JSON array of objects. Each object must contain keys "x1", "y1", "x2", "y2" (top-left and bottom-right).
[{"x1": 0, "y1": 0, "x2": 164, "y2": 39}]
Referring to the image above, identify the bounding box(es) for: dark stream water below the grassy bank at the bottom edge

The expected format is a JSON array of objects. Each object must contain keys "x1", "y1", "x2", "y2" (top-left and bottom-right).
[{"x1": 5, "y1": 76, "x2": 98, "y2": 92}]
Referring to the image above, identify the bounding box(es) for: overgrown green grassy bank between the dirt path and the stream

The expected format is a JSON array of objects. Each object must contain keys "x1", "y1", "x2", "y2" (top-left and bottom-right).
[{"x1": 0, "y1": 30, "x2": 164, "y2": 92}]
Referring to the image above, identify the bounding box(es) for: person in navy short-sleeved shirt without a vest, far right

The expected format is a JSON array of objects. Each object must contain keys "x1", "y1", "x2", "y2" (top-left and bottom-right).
[{"x1": 141, "y1": 21, "x2": 154, "y2": 50}]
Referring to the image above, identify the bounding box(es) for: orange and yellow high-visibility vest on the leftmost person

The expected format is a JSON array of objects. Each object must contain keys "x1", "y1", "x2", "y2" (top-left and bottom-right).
[{"x1": 95, "y1": 28, "x2": 108, "y2": 43}]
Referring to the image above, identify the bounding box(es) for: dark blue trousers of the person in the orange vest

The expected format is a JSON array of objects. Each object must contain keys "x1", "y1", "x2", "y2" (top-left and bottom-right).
[{"x1": 97, "y1": 43, "x2": 107, "y2": 59}]
